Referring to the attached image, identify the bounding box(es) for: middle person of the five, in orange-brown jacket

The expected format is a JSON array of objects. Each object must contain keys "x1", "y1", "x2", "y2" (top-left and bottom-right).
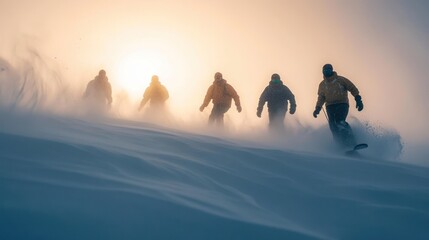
[{"x1": 200, "y1": 72, "x2": 241, "y2": 125}]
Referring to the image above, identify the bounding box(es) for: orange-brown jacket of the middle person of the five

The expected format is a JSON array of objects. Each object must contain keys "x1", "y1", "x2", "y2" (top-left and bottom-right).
[{"x1": 202, "y1": 79, "x2": 241, "y2": 108}]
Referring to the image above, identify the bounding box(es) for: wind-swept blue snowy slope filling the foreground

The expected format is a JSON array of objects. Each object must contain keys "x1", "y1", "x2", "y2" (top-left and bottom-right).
[{"x1": 0, "y1": 112, "x2": 429, "y2": 239}]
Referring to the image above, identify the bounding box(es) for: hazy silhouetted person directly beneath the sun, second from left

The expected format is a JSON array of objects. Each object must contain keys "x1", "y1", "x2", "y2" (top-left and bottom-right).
[{"x1": 138, "y1": 75, "x2": 169, "y2": 111}]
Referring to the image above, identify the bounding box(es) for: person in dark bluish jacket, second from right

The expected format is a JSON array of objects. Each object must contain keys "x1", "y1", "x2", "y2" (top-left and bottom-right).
[{"x1": 256, "y1": 73, "x2": 296, "y2": 129}]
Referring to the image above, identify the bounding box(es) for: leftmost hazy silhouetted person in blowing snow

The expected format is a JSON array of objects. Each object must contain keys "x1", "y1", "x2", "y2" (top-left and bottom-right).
[{"x1": 83, "y1": 69, "x2": 112, "y2": 107}]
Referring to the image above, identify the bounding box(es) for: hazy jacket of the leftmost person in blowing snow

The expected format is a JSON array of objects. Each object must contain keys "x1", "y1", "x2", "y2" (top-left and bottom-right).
[{"x1": 84, "y1": 76, "x2": 112, "y2": 104}]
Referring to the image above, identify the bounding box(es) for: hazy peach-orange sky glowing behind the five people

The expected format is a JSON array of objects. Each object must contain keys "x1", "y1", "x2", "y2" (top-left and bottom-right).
[{"x1": 0, "y1": 0, "x2": 429, "y2": 142}]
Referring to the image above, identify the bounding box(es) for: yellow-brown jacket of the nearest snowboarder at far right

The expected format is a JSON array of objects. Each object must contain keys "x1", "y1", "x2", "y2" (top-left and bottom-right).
[{"x1": 316, "y1": 72, "x2": 359, "y2": 107}]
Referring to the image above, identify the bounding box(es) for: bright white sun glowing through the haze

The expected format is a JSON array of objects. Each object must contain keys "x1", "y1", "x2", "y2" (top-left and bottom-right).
[{"x1": 114, "y1": 50, "x2": 165, "y2": 99}]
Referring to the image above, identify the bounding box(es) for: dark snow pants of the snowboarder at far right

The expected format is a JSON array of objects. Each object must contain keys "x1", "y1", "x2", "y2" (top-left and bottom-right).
[{"x1": 326, "y1": 103, "x2": 356, "y2": 147}]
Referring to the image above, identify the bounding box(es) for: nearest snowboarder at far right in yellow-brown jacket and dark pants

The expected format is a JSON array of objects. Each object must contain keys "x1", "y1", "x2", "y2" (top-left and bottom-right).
[{"x1": 313, "y1": 64, "x2": 363, "y2": 146}]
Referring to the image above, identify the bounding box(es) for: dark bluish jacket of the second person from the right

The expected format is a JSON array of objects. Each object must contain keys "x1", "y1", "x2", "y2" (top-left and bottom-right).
[{"x1": 258, "y1": 81, "x2": 296, "y2": 112}]
